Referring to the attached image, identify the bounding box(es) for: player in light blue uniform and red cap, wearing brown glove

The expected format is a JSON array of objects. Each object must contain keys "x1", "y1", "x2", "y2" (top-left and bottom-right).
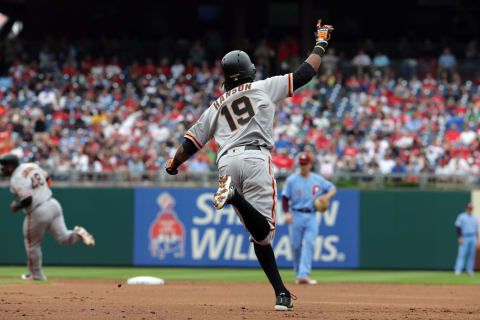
[{"x1": 282, "y1": 153, "x2": 336, "y2": 284}]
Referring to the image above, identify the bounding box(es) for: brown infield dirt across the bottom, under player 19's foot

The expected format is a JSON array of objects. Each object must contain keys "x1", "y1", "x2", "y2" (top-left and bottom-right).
[{"x1": 0, "y1": 279, "x2": 480, "y2": 320}]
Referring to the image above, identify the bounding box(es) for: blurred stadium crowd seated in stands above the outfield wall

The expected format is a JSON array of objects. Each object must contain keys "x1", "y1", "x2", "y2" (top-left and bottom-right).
[{"x1": 0, "y1": 41, "x2": 480, "y2": 179}]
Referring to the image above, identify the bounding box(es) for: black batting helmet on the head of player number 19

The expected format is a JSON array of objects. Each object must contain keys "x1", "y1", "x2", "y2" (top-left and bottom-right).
[{"x1": 222, "y1": 50, "x2": 256, "y2": 90}]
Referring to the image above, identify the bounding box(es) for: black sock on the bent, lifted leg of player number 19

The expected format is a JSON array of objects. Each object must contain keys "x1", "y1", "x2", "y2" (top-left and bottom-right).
[{"x1": 230, "y1": 190, "x2": 270, "y2": 241}]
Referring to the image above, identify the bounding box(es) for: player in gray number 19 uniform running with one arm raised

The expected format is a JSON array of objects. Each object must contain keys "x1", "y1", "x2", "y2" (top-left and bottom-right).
[{"x1": 166, "y1": 21, "x2": 333, "y2": 311}]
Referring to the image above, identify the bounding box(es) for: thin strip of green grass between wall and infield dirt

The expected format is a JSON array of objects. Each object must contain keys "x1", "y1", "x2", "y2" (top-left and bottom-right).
[{"x1": 0, "y1": 266, "x2": 480, "y2": 285}]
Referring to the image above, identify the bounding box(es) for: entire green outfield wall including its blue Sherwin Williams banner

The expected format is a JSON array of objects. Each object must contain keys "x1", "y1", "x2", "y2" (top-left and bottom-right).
[{"x1": 0, "y1": 187, "x2": 472, "y2": 269}]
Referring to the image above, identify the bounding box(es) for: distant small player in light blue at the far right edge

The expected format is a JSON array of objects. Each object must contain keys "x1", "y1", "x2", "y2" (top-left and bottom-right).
[{"x1": 455, "y1": 203, "x2": 478, "y2": 276}]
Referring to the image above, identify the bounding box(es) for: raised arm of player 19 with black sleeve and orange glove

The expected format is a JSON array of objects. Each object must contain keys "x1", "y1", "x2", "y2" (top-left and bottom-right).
[{"x1": 293, "y1": 20, "x2": 333, "y2": 90}]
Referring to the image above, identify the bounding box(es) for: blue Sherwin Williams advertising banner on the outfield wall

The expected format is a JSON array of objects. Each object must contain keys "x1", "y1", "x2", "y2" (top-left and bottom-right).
[{"x1": 134, "y1": 188, "x2": 359, "y2": 268}]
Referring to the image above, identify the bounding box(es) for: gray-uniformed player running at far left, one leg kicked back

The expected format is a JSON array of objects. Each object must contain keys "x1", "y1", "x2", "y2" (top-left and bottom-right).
[{"x1": 0, "y1": 154, "x2": 95, "y2": 280}]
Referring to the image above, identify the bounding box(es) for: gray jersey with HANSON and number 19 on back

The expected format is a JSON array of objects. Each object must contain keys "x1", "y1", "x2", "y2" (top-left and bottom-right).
[{"x1": 185, "y1": 73, "x2": 293, "y2": 162}]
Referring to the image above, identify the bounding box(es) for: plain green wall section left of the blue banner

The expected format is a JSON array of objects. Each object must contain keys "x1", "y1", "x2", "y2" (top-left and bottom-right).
[{"x1": 0, "y1": 188, "x2": 134, "y2": 265}]
